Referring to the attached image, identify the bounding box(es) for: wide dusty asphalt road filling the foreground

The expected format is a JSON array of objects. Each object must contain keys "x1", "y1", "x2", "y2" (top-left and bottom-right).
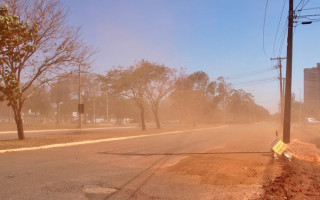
[{"x1": 0, "y1": 124, "x2": 296, "y2": 200}]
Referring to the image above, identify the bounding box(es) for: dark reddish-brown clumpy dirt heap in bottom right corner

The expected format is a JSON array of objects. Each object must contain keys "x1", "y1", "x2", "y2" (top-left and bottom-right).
[{"x1": 257, "y1": 159, "x2": 320, "y2": 200}]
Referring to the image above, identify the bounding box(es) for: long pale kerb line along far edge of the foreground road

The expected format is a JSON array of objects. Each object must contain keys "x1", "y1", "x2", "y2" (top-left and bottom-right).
[{"x1": 0, "y1": 126, "x2": 227, "y2": 153}]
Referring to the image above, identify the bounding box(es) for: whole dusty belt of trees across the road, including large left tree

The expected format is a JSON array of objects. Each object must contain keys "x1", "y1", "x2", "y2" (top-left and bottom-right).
[{"x1": 0, "y1": 0, "x2": 299, "y2": 140}]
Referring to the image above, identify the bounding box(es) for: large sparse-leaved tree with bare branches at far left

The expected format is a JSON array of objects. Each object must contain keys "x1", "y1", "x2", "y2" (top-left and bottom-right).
[{"x1": 0, "y1": 0, "x2": 94, "y2": 140}]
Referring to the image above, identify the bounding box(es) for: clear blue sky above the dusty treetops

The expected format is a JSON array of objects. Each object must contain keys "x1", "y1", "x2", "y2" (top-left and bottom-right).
[{"x1": 63, "y1": 0, "x2": 320, "y2": 112}]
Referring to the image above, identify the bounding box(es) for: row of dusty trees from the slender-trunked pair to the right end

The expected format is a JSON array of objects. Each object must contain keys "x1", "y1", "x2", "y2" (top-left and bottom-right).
[{"x1": 101, "y1": 60, "x2": 270, "y2": 130}]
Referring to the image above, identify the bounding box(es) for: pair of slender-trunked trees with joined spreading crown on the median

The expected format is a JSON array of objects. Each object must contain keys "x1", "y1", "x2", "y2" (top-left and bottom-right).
[{"x1": 102, "y1": 60, "x2": 176, "y2": 130}]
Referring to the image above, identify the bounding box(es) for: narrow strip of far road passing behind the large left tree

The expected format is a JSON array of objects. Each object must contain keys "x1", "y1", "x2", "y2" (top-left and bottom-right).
[{"x1": 0, "y1": 126, "x2": 138, "y2": 140}]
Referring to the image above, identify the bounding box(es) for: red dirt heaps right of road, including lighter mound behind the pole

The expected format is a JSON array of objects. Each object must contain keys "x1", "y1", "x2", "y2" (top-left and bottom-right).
[{"x1": 259, "y1": 140, "x2": 320, "y2": 200}]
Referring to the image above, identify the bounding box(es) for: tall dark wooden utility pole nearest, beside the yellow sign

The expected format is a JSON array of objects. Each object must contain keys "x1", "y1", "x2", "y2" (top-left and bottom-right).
[{"x1": 283, "y1": 0, "x2": 294, "y2": 144}]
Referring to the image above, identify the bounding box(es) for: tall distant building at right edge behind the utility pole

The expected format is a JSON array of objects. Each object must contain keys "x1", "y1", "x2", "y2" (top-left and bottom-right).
[{"x1": 304, "y1": 63, "x2": 320, "y2": 116}]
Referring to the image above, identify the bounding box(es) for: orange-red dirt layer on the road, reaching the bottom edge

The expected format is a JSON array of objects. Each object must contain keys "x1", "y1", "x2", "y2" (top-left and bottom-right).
[{"x1": 167, "y1": 153, "x2": 280, "y2": 200}]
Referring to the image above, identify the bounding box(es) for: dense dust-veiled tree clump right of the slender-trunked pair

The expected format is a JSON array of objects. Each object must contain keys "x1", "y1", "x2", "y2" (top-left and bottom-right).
[{"x1": 170, "y1": 71, "x2": 269, "y2": 125}]
